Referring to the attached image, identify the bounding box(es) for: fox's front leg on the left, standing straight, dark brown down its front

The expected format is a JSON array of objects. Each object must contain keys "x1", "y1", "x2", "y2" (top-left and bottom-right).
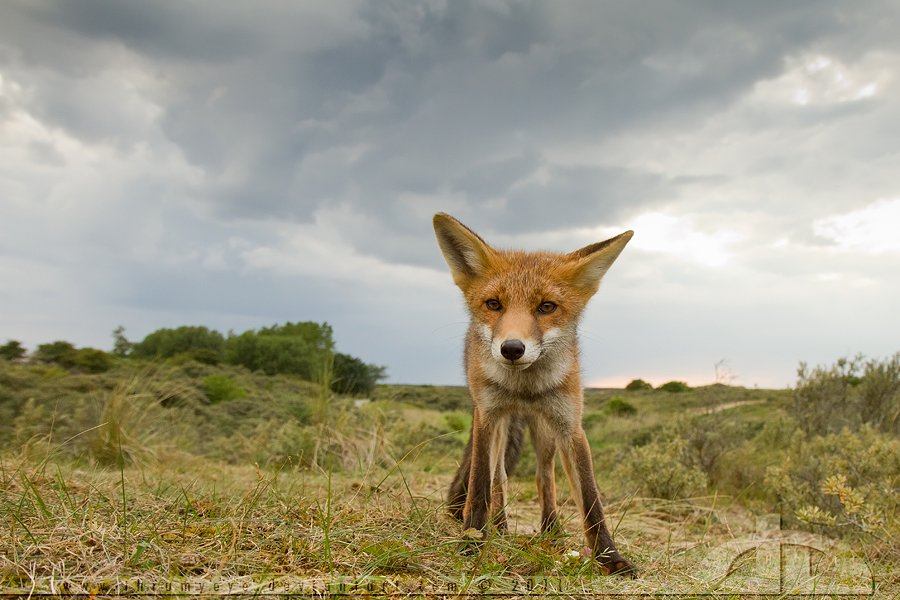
[{"x1": 463, "y1": 406, "x2": 506, "y2": 531}]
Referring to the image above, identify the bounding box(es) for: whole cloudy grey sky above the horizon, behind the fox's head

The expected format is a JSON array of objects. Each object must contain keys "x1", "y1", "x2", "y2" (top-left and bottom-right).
[{"x1": 0, "y1": 0, "x2": 900, "y2": 387}]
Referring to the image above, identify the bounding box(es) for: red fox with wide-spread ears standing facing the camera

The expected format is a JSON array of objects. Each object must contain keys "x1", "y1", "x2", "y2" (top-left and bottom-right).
[{"x1": 434, "y1": 213, "x2": 637, "y2": 577}]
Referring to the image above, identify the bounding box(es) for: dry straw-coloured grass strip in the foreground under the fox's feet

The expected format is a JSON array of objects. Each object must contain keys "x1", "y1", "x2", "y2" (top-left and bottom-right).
[{"x1": 0, "y1": 455, "x2": 896, "y2": 597}]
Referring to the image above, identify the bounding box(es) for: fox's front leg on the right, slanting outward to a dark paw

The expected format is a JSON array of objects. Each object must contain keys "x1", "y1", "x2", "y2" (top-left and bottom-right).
[{"x1": 560, "y1": 426, "x2": 637, "y2": 577}]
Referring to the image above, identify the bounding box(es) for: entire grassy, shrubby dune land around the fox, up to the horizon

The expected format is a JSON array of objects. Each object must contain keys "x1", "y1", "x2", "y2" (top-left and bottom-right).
[{"x1": 0, "y1": 346, "x2": 900, "y2": 596}]
